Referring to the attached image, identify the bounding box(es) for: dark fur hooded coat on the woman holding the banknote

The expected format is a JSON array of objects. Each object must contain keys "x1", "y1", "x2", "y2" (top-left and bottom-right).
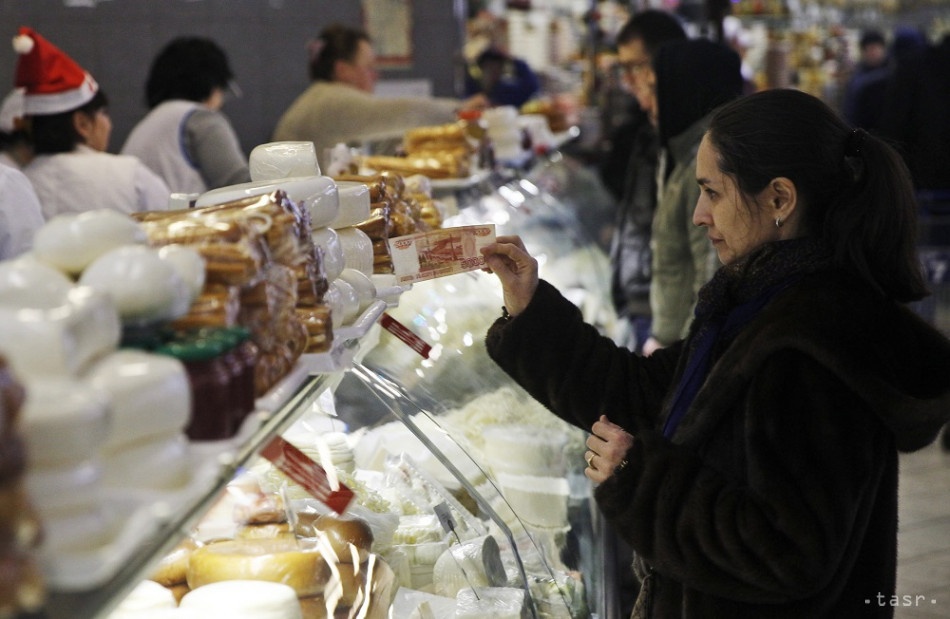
[{"x1": 486, "y1": 270, "x2": 950, "y2": 619}]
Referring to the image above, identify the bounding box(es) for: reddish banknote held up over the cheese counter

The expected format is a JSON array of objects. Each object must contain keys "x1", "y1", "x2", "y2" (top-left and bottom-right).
[{"x1": 389, "y1": 224, "x2": 495, "y2": 284}]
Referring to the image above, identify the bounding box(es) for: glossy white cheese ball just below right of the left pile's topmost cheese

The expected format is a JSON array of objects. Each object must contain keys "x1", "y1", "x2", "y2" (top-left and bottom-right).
[{"x1": 79, "y1": 245, "x2": 192, "y2": 324}]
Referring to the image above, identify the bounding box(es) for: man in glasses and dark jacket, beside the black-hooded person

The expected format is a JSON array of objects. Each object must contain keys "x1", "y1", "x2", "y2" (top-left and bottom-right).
[{"x1": 601, "y1": 9, "x2": 686, "y2": 351}]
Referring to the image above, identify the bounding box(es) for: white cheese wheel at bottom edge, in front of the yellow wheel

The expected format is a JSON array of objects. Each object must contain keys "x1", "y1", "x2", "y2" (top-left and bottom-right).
[{"x1": 180, "y1": 580, "x2": 302, "y2": 619}]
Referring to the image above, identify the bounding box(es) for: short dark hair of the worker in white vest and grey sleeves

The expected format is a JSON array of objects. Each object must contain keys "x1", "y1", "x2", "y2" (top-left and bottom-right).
[{"x1": 145, "y1": 37, "x2": 234, "y2": 109}]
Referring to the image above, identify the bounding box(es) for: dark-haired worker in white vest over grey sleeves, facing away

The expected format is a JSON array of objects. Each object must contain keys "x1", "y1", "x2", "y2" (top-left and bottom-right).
[{"x1": 121, "y1": 37, "x2": 251, "y2": 193}]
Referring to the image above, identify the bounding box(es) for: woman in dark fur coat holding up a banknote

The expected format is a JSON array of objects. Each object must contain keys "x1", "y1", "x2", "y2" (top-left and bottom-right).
[{"x1": 482, "y1": 90, "x2": 950, "y2": 619}]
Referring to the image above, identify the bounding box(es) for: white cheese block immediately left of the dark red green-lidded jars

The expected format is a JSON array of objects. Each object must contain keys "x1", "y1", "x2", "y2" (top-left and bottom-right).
[{"x1": 84, "y1": 349, "x2": 191, "y2": 450}]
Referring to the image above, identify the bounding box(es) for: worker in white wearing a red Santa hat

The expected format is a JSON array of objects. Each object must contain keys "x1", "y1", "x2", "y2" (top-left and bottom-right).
[{"x1": 13, "y1": 27, "x2": 169, "y2": 220}]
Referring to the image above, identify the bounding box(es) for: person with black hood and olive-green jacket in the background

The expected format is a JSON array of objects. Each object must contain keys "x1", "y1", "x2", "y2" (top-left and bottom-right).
[{"x1": 643, "y1": 39, "x2": 743, "y2": 355}]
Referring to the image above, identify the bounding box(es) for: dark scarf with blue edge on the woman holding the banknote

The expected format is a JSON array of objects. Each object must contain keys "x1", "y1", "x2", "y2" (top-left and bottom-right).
[{"x1": 663, "y1": 238, "x2": 830, "y2": 438}]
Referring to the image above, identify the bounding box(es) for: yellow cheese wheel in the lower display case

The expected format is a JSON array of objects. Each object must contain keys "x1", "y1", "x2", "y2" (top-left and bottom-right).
[{"x1": 188, "y1": 538, "x2": 330, "y2": 597}]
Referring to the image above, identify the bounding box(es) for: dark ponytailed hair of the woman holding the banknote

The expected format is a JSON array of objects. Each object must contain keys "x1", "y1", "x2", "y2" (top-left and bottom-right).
[{"x1": 707, "y1": 89, "x2": 928, "y2": 302}]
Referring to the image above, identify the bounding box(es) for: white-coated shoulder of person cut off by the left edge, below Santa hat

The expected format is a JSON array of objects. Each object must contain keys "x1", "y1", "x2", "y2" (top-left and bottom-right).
[{"x1": 0, "y1": 163, "x2": 44, "y2": 260}]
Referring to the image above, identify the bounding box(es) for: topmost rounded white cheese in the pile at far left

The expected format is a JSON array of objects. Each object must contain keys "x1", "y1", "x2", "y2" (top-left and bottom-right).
[{"x1": 33, "y1": 209, "x2": 147, "y2": 275}]
